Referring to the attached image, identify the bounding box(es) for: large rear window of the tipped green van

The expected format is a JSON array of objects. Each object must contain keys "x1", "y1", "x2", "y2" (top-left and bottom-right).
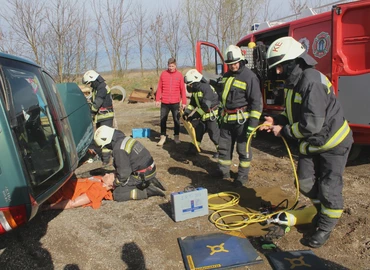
[{"x1": 2, "y1": 60, "x2": 63, "y2": 195}]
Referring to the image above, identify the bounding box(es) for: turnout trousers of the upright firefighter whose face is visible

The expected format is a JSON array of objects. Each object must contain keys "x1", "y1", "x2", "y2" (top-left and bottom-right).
[{"x1": 218, "y1": 123, "x2": 252, "y2": 181}]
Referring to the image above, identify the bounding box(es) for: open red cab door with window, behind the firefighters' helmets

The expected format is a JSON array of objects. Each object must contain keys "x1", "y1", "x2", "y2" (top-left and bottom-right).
[{"x1": 195, "y1": 41, "x2": 227, "y2": 80}]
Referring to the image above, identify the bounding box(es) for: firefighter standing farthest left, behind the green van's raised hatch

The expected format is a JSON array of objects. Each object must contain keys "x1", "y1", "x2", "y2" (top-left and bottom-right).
[{"x1": 82, "y1": 70, "x2": 114, "y2": 165}]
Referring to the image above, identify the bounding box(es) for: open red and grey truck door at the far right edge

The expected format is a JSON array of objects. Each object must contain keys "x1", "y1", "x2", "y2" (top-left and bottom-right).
[{"x1": 332, "y1": 1, "x2": 370, "y2": 144}]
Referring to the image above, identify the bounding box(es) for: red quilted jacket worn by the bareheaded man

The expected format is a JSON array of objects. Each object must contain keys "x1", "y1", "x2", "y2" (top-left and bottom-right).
[{"x1": 155, "y1": 70, "x2": 186, "y2": 104}]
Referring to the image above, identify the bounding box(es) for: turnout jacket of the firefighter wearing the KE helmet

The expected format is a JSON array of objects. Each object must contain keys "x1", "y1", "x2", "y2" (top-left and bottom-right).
[{"x1": 274, "y1": 65, "x2": 351, "y2": 154}]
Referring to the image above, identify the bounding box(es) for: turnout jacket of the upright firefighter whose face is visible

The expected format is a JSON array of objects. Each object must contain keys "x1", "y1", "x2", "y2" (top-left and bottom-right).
[{"x1": 220, "y1": 64, "x2": 263, "y2": 129}]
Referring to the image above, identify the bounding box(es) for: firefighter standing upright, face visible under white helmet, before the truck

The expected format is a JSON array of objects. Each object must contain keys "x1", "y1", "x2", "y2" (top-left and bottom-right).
[{"x1": 218, "y1": 45, "x2": 262, "y2": 187}]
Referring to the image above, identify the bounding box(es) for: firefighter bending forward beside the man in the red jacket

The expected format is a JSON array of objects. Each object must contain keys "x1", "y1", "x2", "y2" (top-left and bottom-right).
[{"x1": 183, "y1": 69, "x2": 220, "y2": 158}]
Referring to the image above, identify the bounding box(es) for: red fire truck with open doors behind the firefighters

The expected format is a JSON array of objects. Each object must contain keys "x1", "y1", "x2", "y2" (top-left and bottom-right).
[{"x1": 196, "y1": 0, "x2": 370, "y2": 159}]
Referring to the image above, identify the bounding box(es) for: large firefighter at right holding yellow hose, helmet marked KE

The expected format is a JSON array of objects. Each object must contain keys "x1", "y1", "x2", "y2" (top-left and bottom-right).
[{"x1": 261, "y1": 37, "x2": 353, "y2": 248}]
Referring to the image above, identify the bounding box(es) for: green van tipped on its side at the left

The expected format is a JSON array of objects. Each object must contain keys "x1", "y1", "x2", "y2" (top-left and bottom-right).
[{"x1": 0, "y1": 53, "x2": 94, "y2": 234}]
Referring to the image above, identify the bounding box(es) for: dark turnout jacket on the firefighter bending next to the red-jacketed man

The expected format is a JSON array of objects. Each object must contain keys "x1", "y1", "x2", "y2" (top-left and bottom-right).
[{"x1": 185, "y1": 81, "x2": 220, "y2": 121}]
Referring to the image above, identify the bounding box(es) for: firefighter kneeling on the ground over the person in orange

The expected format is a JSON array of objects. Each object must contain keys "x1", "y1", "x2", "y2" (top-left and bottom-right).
[{"x1": 94, "y1": 126, "x2": 165, "y2": 201}]
